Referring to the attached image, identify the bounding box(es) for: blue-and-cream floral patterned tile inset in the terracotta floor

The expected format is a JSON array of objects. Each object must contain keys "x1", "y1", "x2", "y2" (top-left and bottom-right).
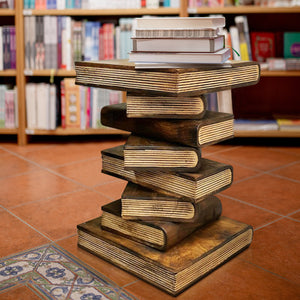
[{"x1": 0, "y1": 244, "x2": 136, "y2": 300}]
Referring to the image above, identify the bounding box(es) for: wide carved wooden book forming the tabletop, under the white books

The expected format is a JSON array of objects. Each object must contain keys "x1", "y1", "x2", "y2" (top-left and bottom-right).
[{"x1": 75, "y1": 60, "x2": 260, "y2": 96}]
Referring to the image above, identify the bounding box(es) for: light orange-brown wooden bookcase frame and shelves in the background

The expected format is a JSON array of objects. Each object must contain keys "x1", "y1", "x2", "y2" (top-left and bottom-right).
[{"x1": 0, "y1": 0, "x2": 300, "y2": 145}]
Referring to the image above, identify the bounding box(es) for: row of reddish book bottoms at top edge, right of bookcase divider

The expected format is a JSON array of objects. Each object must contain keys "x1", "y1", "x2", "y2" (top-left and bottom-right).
[{"x1": 188, "y1": 0, "x2": 300, "y2": 7}]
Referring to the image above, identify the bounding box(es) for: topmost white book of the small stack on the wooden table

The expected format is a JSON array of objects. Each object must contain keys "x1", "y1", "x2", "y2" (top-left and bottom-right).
[{"x1": 134, "y1": 17, "x2": 225, "y2": 29}]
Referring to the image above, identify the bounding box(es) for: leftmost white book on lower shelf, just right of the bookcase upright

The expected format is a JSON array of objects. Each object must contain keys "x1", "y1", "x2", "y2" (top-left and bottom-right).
[{"x1": 25, "y1": 83, "x2": 37, "y2": 129}]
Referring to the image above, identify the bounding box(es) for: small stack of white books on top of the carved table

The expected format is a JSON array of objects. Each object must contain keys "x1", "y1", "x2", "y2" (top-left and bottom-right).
[{"x1": 129, "y1": 17, "x2": 231, "y2": 68}]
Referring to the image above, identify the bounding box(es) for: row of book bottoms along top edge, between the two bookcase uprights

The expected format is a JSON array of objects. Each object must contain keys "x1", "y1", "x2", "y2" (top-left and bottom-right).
[{"x1": 24, "y1": 0, "x2": 180, "y2": 9}]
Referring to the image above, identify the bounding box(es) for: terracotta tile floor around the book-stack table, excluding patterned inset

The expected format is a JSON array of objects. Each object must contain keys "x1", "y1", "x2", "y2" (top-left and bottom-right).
[{"x1": 0, "y1": 137, "x2": 300, "y2": 300}]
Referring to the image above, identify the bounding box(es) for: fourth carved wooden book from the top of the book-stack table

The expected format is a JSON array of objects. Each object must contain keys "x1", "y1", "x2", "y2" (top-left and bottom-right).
[{"x1": 124, "y1": 134, "x2": 201, "y2": 172}]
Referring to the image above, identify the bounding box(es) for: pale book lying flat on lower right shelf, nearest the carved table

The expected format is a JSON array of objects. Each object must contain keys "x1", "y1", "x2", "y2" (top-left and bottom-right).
[{"x1": 233, "y1": 119, "x2": 278, "y2": 131}]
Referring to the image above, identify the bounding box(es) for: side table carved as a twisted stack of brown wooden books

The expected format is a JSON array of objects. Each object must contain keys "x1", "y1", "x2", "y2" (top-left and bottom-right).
[{"x1": 75, "y1": 16, "x2": 260, "y2": 296}]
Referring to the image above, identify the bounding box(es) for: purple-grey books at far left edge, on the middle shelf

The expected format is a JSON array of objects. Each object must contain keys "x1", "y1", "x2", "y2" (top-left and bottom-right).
[{"x1": 0, "y1": 26, "x2": 16, "y2": 70}]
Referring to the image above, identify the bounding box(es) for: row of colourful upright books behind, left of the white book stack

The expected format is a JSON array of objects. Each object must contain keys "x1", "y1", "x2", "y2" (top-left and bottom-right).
[{"x1": 24, "y1": 16, "x2": 133, "y2": 70}]
